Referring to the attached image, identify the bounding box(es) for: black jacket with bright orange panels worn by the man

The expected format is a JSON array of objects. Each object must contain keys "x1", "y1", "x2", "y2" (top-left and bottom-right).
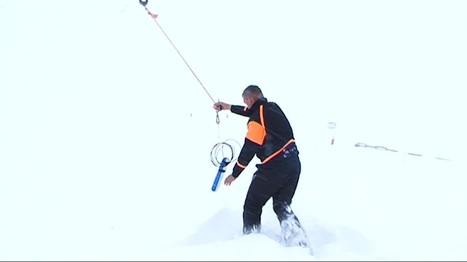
[{"x1": 230, "y1": 97, "x2": 298, "y2": 177}]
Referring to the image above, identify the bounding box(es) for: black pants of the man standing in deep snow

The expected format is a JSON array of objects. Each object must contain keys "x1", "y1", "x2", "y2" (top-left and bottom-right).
[{"x1": 243, "y1": 156, "x2": 301, "y2": 234}]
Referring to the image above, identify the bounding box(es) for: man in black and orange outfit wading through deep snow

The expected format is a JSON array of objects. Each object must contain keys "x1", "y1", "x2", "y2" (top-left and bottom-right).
[{"x1": 213, "y1": 85, "x2": 307, "y2": 246}]
